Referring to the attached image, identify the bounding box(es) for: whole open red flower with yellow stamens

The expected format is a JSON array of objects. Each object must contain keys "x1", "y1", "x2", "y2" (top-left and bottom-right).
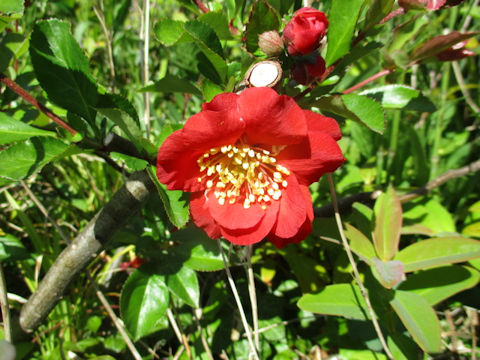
[{"x1": 157, "y1": 87, "x2": 345, "y2": 247}]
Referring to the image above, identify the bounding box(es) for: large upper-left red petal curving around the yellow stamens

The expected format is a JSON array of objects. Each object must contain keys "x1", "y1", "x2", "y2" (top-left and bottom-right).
[{"x1": 157, "y1": 111, "x2": 245, "y2": 192}]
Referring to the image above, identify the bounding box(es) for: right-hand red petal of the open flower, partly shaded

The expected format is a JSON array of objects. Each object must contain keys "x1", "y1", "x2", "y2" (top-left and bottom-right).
[{"x1": 277, "y1": 131, "x2": 345, "y2": 185}]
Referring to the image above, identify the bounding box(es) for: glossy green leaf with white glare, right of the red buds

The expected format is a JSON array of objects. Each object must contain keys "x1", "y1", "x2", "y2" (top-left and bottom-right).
[{"x1": 360, "y1": 84, "x2": 437, "y2": 112}]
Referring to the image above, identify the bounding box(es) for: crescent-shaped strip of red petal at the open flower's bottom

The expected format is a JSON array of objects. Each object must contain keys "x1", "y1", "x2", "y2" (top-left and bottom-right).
[{"x1": 220, "y1": 201, "x2": 279, "y2": 245}]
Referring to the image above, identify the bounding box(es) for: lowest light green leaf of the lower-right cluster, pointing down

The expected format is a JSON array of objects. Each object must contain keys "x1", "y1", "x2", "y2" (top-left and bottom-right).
[{"x1": 390, "y1": 290, "x2": 441, "y2": 353}]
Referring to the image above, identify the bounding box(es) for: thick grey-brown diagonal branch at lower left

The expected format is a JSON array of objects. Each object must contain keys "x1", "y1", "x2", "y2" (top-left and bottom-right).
[{"x1": 20, "y1": 171, "x2": 155, "y2": 332}]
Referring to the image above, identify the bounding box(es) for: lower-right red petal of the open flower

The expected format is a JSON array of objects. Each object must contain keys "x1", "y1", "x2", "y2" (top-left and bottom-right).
[{"x1": 272, "y1": 175, "x2": 312, "y2": 238}]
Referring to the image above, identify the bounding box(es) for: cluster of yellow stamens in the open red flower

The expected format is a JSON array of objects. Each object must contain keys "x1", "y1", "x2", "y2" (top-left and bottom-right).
[{"x1": 197, "y1": 143, "x2": 290, "y2": 209}]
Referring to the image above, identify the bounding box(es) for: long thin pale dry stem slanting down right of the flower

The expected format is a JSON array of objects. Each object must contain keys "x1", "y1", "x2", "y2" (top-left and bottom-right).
[{"x1": 327, "y1": 173, "x2": 393, "y2": 360}]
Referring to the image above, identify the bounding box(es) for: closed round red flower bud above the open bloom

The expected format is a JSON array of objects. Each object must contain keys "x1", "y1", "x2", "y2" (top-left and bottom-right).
[{"x1": 283, "y1": 7, "x2": 328, "y2": 55}]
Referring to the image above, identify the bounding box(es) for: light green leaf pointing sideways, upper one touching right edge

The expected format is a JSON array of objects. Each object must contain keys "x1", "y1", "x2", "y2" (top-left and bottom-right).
[{"x1": 395, "y1": 236, "x2": 480, "y2": 272}]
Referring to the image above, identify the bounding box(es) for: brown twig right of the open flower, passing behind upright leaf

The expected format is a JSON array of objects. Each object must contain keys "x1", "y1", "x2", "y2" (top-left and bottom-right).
[{"x1": 314, "y1": 160, "x2": 480, "y2": 217}]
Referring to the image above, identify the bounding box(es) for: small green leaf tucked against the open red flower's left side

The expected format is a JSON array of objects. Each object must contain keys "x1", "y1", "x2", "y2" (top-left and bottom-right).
[{"x1": 148, "y1": 167, "x2": 190, "y2": 228}]
